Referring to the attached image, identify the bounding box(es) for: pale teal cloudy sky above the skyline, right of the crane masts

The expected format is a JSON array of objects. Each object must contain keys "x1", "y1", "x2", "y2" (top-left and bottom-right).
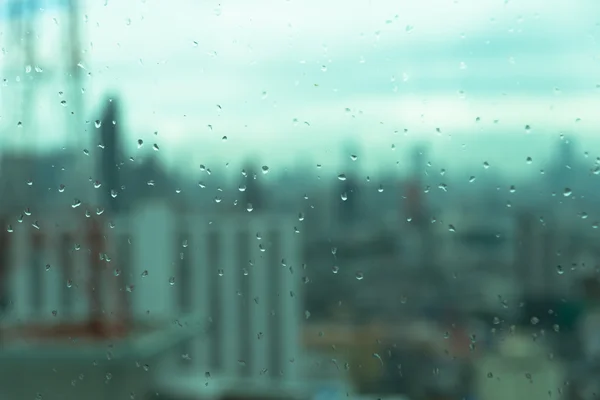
[{"x1": 2, "y1": 0, "x2": 600, "y2": 175}]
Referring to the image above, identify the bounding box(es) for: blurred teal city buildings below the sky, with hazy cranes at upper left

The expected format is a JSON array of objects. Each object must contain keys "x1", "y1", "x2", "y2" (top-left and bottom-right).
[{"x1": 0, "y1": 0, "x2": 600, "y2": 400}]
